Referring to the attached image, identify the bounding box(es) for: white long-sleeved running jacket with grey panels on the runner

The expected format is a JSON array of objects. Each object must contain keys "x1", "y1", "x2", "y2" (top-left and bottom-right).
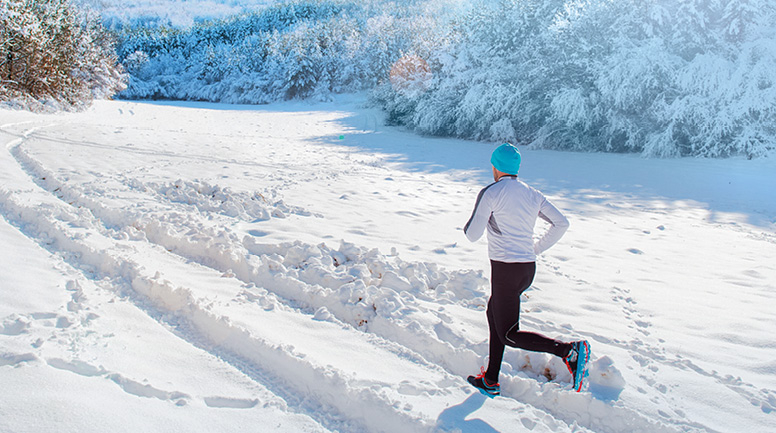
[{"x1": 463, "y1": 176, "x2": 569, "y2": 263}]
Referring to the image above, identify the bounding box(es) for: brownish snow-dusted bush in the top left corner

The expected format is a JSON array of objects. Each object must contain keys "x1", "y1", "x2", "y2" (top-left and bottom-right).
[{"x1": 0, "y1": 0, "x2": 123, "y2": 108}]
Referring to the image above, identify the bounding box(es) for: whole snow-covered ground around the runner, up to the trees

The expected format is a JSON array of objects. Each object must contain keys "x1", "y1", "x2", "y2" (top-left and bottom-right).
[{"x1": 0, "y1": 97, "x2": 776, "y2": 432}]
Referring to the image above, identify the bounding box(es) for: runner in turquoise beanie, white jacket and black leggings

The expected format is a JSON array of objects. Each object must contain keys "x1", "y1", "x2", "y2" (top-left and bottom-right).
[{"x1": 464, "y1": 143, "x2": 590, "y2": 397}]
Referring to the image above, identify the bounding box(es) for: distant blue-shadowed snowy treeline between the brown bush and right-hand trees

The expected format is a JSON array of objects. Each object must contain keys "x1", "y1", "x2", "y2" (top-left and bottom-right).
[{"x1": 112, "y1": 0, "x2": 443, "y2": 104}]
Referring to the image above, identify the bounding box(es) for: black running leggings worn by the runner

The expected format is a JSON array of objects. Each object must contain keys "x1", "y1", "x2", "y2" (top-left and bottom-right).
[{"x1": 485, "y1": 260, "x2": 571, "y2": 383}]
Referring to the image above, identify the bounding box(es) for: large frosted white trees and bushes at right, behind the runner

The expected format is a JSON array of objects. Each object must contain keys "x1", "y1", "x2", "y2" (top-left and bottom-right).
[{"x1": 374, "y1": 0, "x2": 776, "y2": 157}]
